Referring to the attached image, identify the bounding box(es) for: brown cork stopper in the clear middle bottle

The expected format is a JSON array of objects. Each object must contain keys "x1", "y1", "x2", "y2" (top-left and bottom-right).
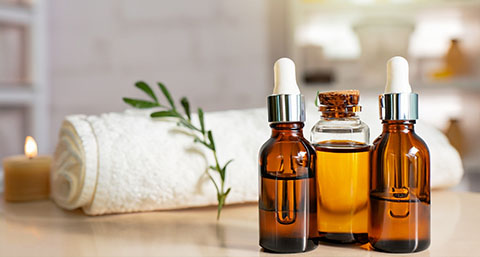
[{"x1": 318, "y1": 90, "x2": 361, "y2": 118}]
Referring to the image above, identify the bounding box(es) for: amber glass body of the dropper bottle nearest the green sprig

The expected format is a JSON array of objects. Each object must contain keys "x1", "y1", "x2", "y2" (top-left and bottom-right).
[{"x1": 259, "y1": 122, "x2": 316, "y2": 253}]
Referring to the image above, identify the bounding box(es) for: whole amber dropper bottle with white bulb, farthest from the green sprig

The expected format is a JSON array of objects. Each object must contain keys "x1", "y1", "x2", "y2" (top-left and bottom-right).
[{"x1": 368, "y1": 56, "x2": 430, "y2": 253}]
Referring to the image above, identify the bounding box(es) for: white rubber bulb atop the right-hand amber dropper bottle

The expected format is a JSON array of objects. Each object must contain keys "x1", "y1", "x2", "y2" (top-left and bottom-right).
[{"x1": 385, "y1": 56, "x2": 412, "y2": 94}]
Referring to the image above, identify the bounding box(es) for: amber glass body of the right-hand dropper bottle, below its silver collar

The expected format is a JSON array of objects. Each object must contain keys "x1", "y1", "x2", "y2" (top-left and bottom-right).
[{"x1": 369, "y1": 120, "x2": 430, "y2": 253}]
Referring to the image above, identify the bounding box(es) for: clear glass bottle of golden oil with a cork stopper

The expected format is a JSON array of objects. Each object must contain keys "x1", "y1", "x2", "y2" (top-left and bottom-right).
[{"x1": 310, "y1": 90, "x2": 370, "y2": 243}]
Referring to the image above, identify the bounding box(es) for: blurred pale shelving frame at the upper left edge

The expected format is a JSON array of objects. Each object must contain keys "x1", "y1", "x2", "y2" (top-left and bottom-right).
[{"x1": 0, "y1": 0, "x2": 51, "y2": 152}]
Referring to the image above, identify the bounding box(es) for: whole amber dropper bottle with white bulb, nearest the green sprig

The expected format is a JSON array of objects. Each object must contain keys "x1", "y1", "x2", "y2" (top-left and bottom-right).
[{"x1": 258, "y1": 58, "x2": 317, "y2": 253}]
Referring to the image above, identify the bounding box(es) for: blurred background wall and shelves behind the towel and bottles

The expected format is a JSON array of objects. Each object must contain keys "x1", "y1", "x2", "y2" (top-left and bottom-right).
[{"x1": 0, "y1": 0, "x2": 480, "y2": 188}]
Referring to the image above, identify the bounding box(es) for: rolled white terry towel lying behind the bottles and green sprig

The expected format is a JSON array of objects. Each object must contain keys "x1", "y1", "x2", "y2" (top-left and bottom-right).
[{"x1": 51, "y1": 106, "x2": 463, "y2": 215}]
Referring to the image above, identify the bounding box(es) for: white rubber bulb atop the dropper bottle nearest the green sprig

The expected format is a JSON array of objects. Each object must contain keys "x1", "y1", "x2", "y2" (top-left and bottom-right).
[{"x1": 273, "y1": 58, "x2": 300, "y2": 95}]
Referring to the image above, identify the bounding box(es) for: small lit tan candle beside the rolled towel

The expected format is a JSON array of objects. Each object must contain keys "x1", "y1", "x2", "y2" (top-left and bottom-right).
[{"x1": 3, "y1": 136, "x2": 52, "y2": 202}]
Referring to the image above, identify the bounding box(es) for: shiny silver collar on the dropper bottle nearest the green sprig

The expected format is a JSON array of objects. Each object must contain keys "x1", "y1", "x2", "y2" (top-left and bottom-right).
[{"x1": 267, "y1": 94, "x2": 305, "y2": 122}]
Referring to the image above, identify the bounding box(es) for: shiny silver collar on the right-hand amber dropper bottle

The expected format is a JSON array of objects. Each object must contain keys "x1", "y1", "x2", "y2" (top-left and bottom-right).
[{"x1": 379, "y1": 93, "x2": 418, "y2": 120}]
